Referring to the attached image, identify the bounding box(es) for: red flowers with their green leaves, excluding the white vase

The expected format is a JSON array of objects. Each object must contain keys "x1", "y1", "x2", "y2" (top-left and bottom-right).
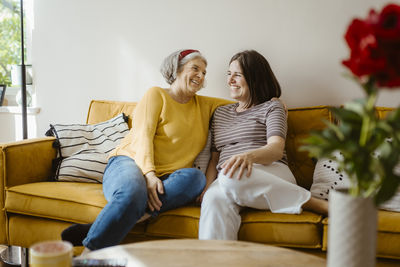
[{"x1": 302, "y1": 4, "x2": 400, "y2": 205}]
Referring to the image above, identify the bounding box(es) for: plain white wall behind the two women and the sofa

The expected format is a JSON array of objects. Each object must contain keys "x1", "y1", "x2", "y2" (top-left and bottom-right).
[{"x1": 32, "y1": 0, "x2": 400, "y2": 136}]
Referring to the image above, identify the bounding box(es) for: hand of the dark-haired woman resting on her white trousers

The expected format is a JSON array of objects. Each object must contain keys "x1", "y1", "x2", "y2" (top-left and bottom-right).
[{"x1": 221, "y1": 153, "x2": 254, "y2": 180}]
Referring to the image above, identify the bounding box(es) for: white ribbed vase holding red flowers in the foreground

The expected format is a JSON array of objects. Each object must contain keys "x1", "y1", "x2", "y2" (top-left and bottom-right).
[{"x1": 328, "y1": 190, "x2": 377, "y2": 267}]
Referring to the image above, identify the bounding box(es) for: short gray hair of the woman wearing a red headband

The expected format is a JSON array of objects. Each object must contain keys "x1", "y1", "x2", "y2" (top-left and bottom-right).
[{"x1": 160, "y1": 49, "x2": 207, "y2": 84}]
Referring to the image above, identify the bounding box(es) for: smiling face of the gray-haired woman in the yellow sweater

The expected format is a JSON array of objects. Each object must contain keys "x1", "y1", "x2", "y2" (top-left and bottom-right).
[{"x1": 176, "y1": 58, "x2": 207, "y2": 95}]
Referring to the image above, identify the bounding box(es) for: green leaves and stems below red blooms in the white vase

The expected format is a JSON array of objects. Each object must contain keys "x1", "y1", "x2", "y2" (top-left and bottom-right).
[{"x1": 300, "y1": 78, "x2": 400, "y2": 204}]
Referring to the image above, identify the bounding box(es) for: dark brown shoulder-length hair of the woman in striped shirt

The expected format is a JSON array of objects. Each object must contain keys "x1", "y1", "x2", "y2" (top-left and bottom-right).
[{"x1": 229, "y1": 50, "x2": 281, "y2": 107}]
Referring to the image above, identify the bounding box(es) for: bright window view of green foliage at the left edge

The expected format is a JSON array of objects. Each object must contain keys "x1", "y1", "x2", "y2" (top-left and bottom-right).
[{"x1": 0, "y1": 0, "x2": 21, "y2": 85}]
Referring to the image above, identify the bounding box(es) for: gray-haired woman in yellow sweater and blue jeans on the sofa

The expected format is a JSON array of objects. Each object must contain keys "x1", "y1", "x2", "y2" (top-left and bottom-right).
[{"x1": 62, "y1": 50, "x2": 231, "y2": 250}]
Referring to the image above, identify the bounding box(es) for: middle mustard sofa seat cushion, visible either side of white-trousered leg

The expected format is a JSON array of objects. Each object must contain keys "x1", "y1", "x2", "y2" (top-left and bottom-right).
[{"x1": 146, "y1": 206, "x2": 322, "y2": 248}]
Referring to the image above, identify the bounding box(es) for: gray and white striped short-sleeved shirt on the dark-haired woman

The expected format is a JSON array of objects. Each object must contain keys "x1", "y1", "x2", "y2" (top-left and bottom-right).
[{"x1": 211, "y1": 101, "x2": 287, "y2": 170}]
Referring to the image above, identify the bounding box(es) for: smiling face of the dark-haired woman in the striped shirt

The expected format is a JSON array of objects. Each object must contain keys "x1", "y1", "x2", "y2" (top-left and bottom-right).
[{"x1": 227, "y1": 60, "x2": 250, "y2": 104}]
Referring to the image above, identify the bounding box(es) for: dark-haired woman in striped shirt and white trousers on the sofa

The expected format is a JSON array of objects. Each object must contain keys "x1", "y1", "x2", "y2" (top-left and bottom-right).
[{"x1": 199, "y1": 50, "x2": 328, "y2": 240}]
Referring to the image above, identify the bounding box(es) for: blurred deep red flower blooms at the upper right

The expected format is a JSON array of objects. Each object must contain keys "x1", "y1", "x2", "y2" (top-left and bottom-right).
[{"x1": 343, "y1": 4, "x2": 400, "y2": 87}]
